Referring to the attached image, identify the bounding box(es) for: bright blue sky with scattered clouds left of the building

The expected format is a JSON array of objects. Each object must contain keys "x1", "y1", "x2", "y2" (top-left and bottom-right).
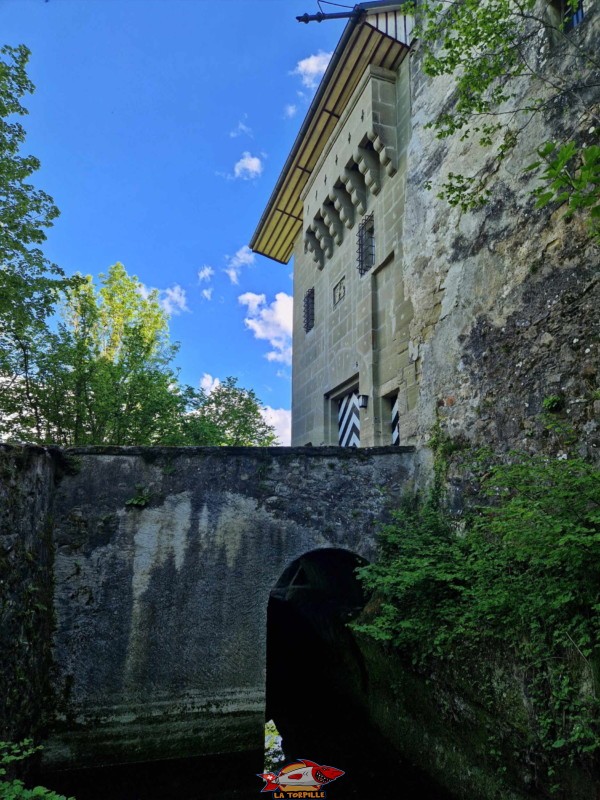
[{"x1": 0, "y1": 0, "x2": 344, "y2": 443}]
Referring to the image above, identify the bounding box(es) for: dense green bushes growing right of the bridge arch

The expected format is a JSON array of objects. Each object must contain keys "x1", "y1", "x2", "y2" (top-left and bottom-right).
[{"x1": 355, "y1": 454, "x2": 600, "y2": 767}]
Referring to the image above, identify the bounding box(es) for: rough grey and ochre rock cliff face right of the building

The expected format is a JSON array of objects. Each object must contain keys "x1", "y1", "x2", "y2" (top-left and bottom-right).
[{"x1": 401, "y1": 3, "x2": 600, "y2": 466}]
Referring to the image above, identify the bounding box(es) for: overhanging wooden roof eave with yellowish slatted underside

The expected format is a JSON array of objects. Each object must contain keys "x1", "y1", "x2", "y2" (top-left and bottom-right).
[{"x1": 250, "y1": 2, "x2": 412, "y2": 264}]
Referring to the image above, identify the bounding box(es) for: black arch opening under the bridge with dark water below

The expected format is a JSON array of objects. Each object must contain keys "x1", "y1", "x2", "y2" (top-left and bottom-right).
[{"x1": 266, "y1": 548, "x2": 451, "y2": 800}]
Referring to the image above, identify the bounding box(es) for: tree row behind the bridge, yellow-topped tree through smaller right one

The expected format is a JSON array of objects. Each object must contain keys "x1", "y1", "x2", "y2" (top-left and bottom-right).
[{"x1": 0, "y1": 263, "x2": 275, "y2": 446}]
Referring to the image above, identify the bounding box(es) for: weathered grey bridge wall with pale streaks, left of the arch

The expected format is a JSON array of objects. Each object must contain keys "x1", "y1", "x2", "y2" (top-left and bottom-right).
[{"x1": 44, "y1": 447, "x2": 412, "y2": 767}]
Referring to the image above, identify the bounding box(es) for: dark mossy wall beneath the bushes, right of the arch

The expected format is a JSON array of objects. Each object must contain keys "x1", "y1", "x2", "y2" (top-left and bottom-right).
[{"x1": 354, "y1": 637, "x2": 597, "y2": 800}]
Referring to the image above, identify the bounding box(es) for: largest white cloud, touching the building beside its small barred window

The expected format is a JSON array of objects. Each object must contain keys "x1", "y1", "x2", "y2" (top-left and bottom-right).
[{"x1": 238, "y1": 292, "x2": 293, "y2": 364}]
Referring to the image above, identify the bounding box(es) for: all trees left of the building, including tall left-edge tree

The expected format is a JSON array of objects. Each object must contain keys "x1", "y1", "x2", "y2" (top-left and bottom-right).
[{"x1": 0, "y1": 50, "x2": 275, "y2": 446}]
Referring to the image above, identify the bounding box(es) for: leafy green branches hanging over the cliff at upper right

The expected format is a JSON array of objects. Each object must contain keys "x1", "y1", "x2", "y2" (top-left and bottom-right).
[{"x1": 414, "y1": 0, "x2": 600, "y2": 241}]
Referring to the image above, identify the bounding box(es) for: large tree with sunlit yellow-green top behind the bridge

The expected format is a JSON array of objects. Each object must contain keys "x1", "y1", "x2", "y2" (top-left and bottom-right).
[{"x1": 4, "y1": 264, "x2": 181, "y2": 445}]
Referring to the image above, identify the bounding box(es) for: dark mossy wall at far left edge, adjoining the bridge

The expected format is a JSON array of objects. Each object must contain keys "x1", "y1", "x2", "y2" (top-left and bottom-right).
[{"x1": 0, "y1": 445, "x2": 57, "y2": 741}]
